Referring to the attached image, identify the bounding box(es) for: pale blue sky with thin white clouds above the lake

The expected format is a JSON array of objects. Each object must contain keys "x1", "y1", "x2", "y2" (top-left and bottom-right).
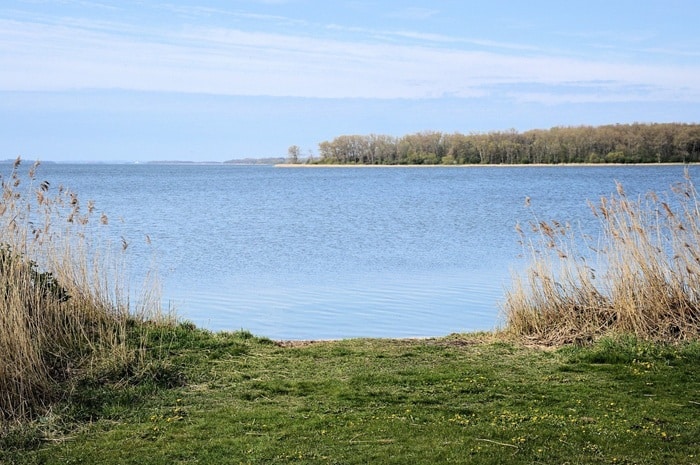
[{"x1": 0, "y1": 0, "x2": 700, "y2": 162}]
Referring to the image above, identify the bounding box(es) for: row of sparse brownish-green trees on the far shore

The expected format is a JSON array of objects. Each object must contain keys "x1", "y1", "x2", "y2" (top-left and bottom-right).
[{"x1": 308, "y1": 123, "x2": 700, "y2": 165}]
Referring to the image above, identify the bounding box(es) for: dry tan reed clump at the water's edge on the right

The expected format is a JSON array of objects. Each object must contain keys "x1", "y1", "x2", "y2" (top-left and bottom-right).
[{"x1": 503, "y1": 170, "x2": 700, "y2": 344}]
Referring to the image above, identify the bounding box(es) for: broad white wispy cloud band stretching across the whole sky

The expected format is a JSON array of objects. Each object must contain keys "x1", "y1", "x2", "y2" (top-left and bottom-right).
[{"x1": 0, "y1": 18, "x2": 700, "y2": 102}]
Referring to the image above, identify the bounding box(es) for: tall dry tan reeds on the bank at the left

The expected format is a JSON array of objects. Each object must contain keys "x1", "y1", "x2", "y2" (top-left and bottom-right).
[{"x1": 0, "y1": 158, "x2": 168, "y2": 422}]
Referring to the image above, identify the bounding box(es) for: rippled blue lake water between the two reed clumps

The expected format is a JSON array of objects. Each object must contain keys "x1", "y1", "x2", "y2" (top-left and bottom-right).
[{"x1": 26, "y1": 164, "x2": 697, "y2": 339}]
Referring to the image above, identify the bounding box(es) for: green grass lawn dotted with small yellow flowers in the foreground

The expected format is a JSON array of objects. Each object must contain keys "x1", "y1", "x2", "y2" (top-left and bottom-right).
[{"x1": 5, "y1": 325, "x2": 700, "y2": 465}]
